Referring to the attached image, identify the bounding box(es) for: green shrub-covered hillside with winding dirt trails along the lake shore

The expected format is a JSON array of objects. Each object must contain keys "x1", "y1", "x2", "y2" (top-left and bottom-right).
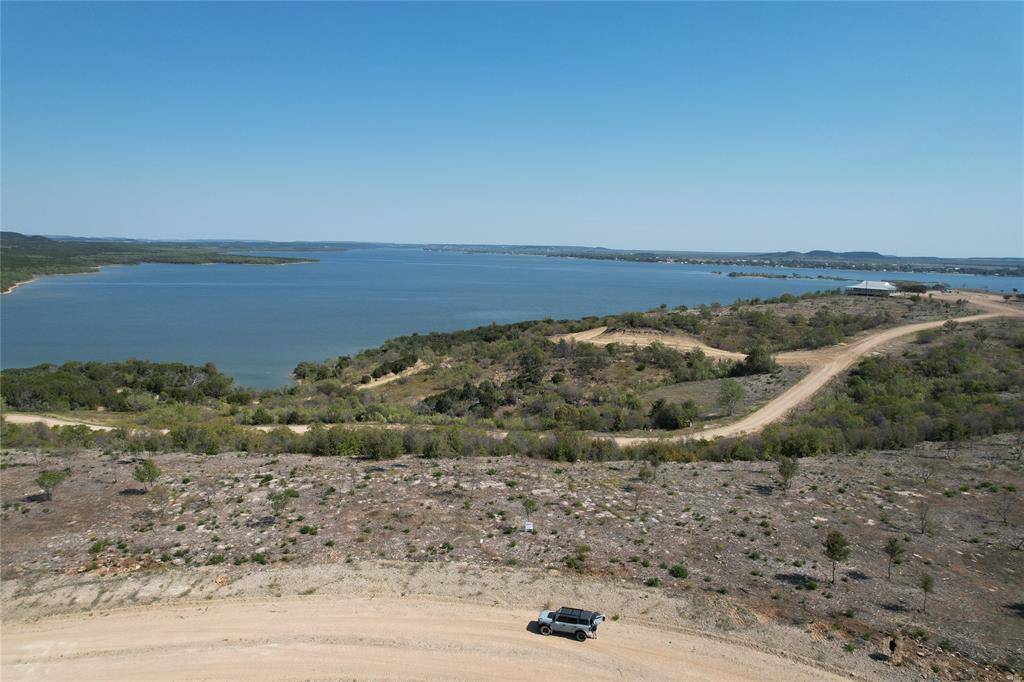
[{"x1": 0, "y1": 284, "x2": 1024, "y2": 460}]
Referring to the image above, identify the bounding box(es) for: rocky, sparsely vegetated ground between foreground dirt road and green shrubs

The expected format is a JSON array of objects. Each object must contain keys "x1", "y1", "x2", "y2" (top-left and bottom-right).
[{"x1": 0, "y1": 437, "x2": 1024, "y2": 677}]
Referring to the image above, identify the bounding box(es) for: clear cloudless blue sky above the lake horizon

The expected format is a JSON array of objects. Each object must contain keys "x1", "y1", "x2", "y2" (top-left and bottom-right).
[{"x1": 2, "y1": 2, "x2": 1024, "y2": 256}]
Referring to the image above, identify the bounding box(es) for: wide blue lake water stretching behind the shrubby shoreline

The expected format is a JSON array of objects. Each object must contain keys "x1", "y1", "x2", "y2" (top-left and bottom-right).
[{"x1": 0, "y1": 248, "x2": 1024, "y2": 387}]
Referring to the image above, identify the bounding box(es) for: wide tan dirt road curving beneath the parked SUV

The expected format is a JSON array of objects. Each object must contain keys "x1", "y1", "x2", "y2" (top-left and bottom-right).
[{"x1": 0, "y1": 597, "x2": 846, "y2": 682}]
